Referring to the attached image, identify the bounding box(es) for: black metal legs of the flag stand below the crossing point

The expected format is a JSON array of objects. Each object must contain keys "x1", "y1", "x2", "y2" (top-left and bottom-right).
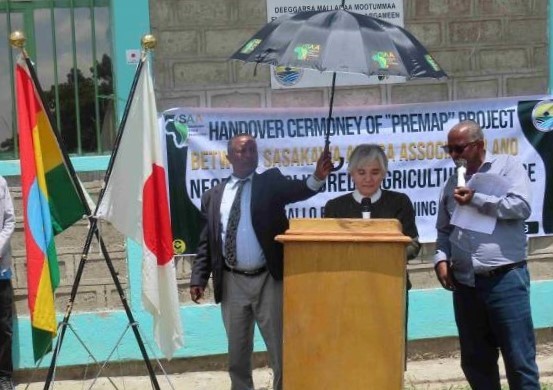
[{"x1": 44, "y1": 221, "x2": 164, "y2": 390}]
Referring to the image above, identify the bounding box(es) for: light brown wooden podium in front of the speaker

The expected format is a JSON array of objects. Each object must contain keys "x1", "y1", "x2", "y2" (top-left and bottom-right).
[{"x1": 276, "y1": 219, "x2": 411, "y2": 390}]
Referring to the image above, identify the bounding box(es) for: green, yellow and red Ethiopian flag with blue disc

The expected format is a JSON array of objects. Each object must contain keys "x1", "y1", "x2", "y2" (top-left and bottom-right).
[{"x1": 15, "y1": 59, "x2": 86, "y2": 361}]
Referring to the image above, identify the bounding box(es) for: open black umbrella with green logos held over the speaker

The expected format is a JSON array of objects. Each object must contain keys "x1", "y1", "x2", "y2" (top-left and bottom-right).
[{"x1": 230, "y1": 6, "x2": 447, "y2": 166}]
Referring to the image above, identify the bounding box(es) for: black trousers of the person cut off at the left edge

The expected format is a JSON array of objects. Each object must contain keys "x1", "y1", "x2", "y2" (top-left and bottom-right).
[{"x1": 0, "y1": 280, "x2": 13, "y2": 377}]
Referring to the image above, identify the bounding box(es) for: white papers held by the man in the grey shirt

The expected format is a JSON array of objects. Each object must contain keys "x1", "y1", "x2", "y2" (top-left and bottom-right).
[{"x1": 451, "y1": 173, "x2": 510, "y2": 234}]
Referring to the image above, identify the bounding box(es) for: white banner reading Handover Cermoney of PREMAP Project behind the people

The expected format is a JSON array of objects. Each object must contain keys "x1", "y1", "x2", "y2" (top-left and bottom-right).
[{"x1": 164, "y1": 96, "x2": 553, "y2": 247}]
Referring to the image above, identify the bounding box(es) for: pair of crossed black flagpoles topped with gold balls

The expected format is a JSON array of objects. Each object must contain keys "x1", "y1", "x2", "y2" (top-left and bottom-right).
[{"x1": 10, "y1": 31, "x2": 159, "y2": 390}]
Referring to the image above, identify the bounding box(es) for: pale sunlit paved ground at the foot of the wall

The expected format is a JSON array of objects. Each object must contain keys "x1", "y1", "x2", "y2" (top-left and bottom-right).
[{"x1": 16, "y1": 344, "x2": 553, "y2": 390}]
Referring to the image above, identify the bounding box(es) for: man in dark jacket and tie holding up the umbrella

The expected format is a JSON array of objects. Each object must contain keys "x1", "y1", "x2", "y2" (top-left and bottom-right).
[{"x1": 190, "y1": 134, "x2": 332, "y2": 390}]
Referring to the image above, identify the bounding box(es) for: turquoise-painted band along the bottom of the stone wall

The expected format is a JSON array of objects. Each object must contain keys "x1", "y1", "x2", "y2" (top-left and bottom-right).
[{"x1": 7, "y1": 280, "x2": 553, "y2": 369}]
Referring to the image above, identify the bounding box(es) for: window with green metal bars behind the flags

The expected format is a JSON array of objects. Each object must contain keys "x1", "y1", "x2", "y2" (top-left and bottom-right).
[{"x1": 0, "y1": 0, "x2": 116, "y2": 159}]
